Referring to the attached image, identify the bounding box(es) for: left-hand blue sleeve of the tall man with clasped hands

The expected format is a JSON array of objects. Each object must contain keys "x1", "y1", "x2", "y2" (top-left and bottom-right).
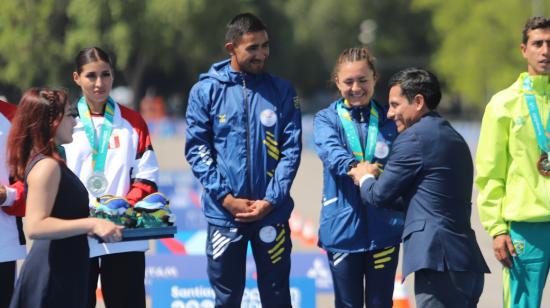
[{"x1": 185, "y1": 83, "x2": 231, "y2": 200}]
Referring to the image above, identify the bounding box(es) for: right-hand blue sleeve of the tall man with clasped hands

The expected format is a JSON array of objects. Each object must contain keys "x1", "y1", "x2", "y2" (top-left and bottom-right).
[{"x1": 264, "y1": 86, "x2": 302, "y2": 208}]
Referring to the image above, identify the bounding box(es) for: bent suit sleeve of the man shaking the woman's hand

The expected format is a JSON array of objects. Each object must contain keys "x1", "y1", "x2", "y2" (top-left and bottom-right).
[{"x1": 360, "y1": 132, "x2": 423, "y2": 208}]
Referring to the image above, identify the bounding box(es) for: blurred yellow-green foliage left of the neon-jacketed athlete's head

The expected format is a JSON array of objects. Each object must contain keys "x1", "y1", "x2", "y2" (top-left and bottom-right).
[{"x1": 413, "y1": 0, "x2": 550, "y2": 108}]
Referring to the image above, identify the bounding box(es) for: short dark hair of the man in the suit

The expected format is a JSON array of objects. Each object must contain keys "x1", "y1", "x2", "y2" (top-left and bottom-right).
[{"x1": 389, "y1": 67, "x2": 441, "y2": 110}]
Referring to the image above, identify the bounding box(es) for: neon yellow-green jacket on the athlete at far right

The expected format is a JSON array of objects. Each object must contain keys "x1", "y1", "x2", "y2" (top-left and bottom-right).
[{"x1": 475, "y1": 73, "x2": 550, "y2": 237}]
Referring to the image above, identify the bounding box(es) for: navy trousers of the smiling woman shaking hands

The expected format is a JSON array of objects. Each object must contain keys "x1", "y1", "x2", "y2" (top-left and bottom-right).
[{"x1": 327, "y1": 245, "x2": 399, "y2": 308}]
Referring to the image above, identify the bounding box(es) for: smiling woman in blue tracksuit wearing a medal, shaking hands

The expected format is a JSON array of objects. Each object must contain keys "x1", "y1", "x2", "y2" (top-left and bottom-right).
[{"x1": 314, "y1": 48, "x2": 403, "y2": 308}]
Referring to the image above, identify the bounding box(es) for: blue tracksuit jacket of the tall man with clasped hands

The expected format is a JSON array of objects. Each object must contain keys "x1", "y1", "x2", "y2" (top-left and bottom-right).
[{"x1": 185, "y1": 60, "x2": 302, "y2": 227}]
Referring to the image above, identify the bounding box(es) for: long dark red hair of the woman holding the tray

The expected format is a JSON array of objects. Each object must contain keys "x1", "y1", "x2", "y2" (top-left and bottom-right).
[{"x1": 8, "y1": 88, "x2": 68, "y2": 180}]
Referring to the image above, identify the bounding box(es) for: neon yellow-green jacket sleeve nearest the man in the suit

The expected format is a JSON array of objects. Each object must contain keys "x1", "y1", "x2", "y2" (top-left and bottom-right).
[{"x1": 475, "y1": 102, "x2": 510, "y2": 237}]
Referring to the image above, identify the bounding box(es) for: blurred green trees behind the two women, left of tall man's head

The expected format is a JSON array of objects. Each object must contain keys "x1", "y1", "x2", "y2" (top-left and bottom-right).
[{"x1": 0, "y1": 0, "x2": 244, "y2": 108}]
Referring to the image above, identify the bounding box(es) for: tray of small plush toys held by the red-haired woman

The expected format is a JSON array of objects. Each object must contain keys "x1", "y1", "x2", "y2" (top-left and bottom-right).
[{"x1": 90, "y1": 193, "x2": 177, "y2": 243}]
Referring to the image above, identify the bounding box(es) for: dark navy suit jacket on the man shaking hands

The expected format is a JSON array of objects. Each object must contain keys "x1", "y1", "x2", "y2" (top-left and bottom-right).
[{"x1": 361, "y1": 112, "x2": 489, "y2": 277}]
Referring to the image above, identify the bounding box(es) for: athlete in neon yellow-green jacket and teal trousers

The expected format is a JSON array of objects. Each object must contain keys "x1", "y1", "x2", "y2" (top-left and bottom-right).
[{"x1": 475, "y1": 17, "x2": 550, "y2": 307}]
